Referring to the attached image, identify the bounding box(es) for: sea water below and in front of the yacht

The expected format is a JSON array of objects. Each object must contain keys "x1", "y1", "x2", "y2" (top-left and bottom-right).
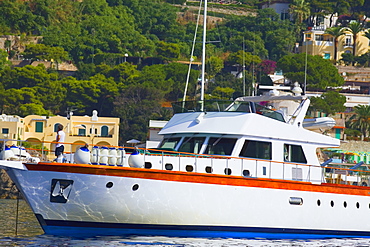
[{"x1": 0, "y1": 199, "x2": 370, "y2": 247}]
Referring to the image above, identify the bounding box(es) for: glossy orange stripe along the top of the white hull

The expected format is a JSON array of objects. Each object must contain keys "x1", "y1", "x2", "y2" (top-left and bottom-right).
[{"x1": 25, "y1": 163, "x2": 370, "y2": 196}]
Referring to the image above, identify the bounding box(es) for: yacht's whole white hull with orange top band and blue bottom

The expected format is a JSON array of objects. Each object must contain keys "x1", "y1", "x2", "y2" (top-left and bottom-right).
[{"x1": 2, "y1": 163, "x2": 370, "y2": 238}]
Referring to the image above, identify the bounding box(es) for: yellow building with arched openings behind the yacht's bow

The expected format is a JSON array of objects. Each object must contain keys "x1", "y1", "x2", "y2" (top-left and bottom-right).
[{"x1": 0, "y1": 111, "x2": 119, "y2": 159}]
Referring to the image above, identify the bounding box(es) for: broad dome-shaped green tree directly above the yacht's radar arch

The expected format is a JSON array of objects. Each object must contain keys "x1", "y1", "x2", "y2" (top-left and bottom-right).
[{"x1": 277, "y1": 53, "x2": 344, "y2": 89}]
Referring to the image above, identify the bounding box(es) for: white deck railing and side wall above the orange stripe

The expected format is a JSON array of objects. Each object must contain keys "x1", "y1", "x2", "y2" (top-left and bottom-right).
[{"x1": 3, "y1": 140, "x2": 370, "y2": 186}]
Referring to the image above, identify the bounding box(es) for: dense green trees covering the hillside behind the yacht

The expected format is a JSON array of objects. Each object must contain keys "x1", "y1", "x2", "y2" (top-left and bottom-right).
[{"x1": 0, "y1": 0, "x2": 370, "y2": 142}]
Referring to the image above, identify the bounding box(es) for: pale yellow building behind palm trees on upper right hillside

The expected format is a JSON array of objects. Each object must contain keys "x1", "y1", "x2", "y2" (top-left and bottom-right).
[{"x1": 300, "y1": 26, "x2": 370, "y2": 60}]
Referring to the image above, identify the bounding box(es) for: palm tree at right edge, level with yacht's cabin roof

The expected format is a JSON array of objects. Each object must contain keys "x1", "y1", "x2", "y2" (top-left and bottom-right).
[{"x1": 350, "y1": 105, "x2": 370, "y2": 137}]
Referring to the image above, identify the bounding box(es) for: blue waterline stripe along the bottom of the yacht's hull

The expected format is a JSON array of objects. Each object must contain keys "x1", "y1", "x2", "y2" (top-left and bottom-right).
[{"x1": 37, "y1": 215, "x2": 370, "y2": 238}]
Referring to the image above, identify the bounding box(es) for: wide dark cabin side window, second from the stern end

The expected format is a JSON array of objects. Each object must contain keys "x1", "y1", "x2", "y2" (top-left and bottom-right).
[{"x1": 240, "y1": 140, "x2": 271, "y2": 160}]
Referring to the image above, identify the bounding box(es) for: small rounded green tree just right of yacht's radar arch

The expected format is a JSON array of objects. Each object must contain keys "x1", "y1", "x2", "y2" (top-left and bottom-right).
[{"x1": 310, "y1": 91, "x2": 346, "y2": 115}]
